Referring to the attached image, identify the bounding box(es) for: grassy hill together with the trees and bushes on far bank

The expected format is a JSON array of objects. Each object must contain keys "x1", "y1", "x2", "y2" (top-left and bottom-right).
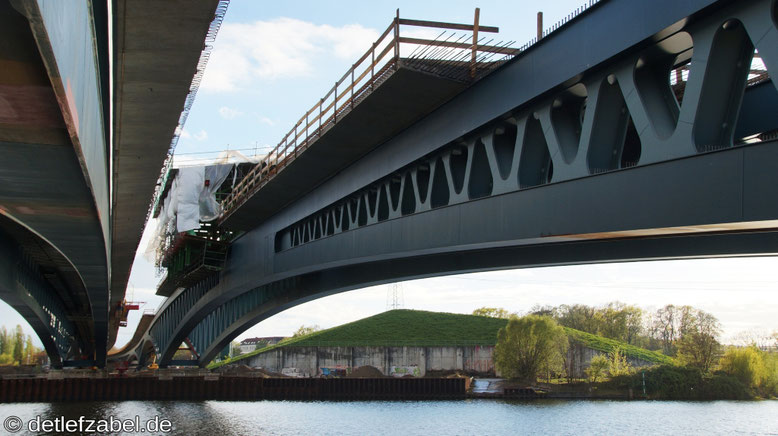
[{"x1": 208, "y1": 303, "x2": 778, "y2": 400}]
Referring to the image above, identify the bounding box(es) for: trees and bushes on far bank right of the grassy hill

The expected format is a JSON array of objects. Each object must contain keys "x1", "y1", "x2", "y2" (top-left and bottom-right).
[{"x1": 495, "y1": 304, "x2": 778, "y2": 400}]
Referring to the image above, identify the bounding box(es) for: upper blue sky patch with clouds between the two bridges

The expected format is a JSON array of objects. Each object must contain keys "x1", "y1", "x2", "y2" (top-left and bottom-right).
[{"x1": 171, "y1": 0, "x2": 596, "y2": 162}]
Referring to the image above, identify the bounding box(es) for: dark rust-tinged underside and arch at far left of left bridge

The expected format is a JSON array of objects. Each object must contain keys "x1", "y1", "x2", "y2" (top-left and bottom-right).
[{"x1": 0, "y1": 2, "x2": 108, "y2": 365}]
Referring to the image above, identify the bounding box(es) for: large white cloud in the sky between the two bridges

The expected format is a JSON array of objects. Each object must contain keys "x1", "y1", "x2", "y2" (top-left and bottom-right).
[{"x1": 201, "y1": 18, "x2": 378, "y2": 92}]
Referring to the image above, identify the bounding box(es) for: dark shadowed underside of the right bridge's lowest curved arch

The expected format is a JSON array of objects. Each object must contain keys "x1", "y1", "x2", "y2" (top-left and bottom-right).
[{"x1": 190, "y1": 230, "x2": 778, "y2": 366}]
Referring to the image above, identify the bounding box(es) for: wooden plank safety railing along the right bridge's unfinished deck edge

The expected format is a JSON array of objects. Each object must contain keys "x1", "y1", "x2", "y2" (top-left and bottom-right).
[{"x1": 222, "y1": 9, "x2": 519, "y2": 219}]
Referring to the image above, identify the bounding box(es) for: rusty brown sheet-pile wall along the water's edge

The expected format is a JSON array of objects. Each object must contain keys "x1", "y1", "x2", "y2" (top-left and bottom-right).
[{"x1": 0, "y1": 374, "x2": 470, "y2": 403}]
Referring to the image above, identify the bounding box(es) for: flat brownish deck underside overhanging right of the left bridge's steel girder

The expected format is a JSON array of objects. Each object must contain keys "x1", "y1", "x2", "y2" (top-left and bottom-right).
[{"x1": 109, "y1": 0, "x2": 226, "y2": 345}]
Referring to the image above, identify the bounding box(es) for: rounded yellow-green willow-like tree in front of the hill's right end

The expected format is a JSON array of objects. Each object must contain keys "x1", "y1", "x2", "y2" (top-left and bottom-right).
[{"x1": 494, "y1": 315, "x2": 568, "y2": 383}]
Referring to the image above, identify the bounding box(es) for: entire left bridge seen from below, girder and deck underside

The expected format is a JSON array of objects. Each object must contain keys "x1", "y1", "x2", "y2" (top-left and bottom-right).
[{"x1": 0, "y1": 0, "x2": 226, "y2": 365}]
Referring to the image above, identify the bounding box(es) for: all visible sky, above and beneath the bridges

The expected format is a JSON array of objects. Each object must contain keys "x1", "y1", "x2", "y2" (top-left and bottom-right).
[{"x1": 0, "y1": 0, "x2": 778, "y2": 346}]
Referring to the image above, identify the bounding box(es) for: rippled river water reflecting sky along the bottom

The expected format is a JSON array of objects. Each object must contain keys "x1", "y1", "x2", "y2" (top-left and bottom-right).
[{"x1": 0, "y1": 400, "x2": 778, "y2": 436}]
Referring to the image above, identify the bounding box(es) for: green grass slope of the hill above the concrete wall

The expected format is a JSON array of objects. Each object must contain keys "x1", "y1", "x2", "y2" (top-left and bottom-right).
[{"x1": 209, "y1": 310, "x2": 673, "y2": 369}]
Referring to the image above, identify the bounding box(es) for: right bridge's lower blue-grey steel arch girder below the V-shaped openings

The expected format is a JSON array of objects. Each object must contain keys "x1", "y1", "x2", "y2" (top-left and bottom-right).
[{"x1": 152, "y1": 142, "x2": 778, "y2": 365}]
